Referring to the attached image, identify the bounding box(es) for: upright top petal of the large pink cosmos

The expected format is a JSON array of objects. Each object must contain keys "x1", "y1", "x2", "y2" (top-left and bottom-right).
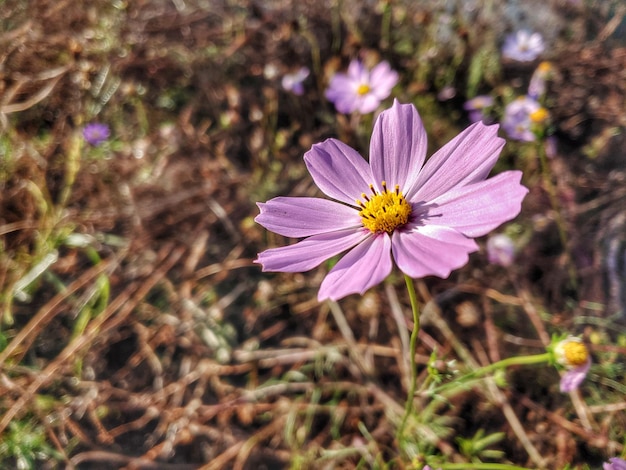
[{"x1": 370, "y1": 100, "x2": 427, "y2": 196}]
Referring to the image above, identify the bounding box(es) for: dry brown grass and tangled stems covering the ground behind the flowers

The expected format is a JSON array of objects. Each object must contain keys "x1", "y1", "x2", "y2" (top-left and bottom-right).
[{"x1": 0, "y1": 0, "x2": 626, "y2": 469}]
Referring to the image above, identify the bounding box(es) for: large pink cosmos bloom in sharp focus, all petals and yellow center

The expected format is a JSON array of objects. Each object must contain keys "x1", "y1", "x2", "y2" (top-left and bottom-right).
[{"x1": 255, "y1": 101, "x2": 528, "y2": 300}]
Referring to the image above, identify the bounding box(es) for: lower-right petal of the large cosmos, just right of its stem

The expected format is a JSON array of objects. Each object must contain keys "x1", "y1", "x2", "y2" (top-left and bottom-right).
[{"x1": 391, "y1": 225, "x2": 478, "y2": 278}]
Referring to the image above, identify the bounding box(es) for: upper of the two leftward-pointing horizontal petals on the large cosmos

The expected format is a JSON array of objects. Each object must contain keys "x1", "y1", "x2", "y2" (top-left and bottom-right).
[{"x1": 254, "y1": 197, "x2": 361, "y2": 238}]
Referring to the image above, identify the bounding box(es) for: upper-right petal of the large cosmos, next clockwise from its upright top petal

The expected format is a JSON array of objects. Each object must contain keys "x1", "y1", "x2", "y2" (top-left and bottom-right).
[{"x1": 405, "y1": 122, "x2": 504, "y2": 202}]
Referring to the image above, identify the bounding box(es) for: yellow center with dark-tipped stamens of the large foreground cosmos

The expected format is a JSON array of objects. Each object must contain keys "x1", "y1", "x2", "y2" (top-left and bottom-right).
[{"x1": 357, "y1": 181, "x2": 411, "y2": 234}]
